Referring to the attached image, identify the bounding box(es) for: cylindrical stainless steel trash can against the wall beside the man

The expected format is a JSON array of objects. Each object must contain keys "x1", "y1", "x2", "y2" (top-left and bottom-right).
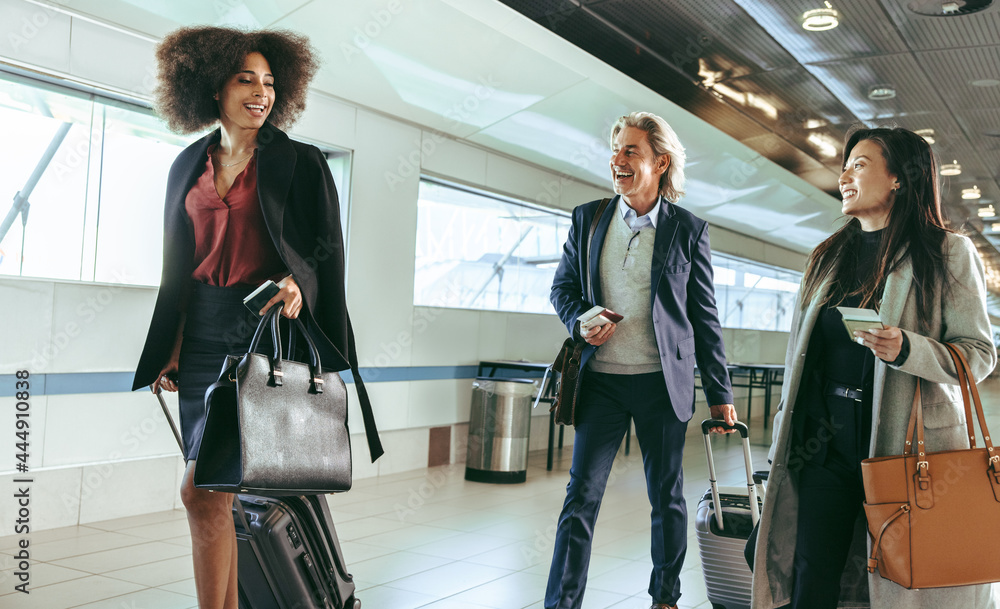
[{"x1": 465, "y1": 377, "x2": 535, "y2": 484}]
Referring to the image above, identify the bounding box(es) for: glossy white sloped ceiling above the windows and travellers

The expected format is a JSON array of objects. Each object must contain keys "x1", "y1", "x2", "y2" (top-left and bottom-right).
[{"x1": 33, "y1": 0, "x2": 841, "y2": 253}]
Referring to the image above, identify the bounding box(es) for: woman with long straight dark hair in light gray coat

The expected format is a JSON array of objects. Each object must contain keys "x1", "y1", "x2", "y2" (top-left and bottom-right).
[{"x1": 754, "y1": 128, "x2": 996, "y2": 609}]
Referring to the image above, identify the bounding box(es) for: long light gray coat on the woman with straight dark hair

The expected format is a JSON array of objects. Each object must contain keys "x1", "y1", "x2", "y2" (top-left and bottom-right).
[{"x1": 752, "y1": 234, "x2": 1000, "y2": 609}]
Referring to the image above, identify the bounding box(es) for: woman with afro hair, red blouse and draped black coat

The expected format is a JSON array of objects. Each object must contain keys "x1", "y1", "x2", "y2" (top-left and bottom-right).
[{"x1": 133, "y1": 27, "x2": 382, "y2": 609}]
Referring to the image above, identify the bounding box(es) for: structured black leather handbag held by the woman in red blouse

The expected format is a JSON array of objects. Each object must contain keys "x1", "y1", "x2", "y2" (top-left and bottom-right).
[{"x1": 194, "y1": 304, "x2": 351, "y2": 495}]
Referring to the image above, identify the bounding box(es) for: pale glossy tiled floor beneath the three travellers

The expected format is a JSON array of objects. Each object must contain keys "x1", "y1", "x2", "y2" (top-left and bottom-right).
[{"x1": 0, "y1": 380, "x2": 1000, "y2": 609}]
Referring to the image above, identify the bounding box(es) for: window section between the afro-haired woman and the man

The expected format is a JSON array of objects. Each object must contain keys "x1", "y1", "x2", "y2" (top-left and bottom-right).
[{"x1": 413, "y1": 179, "x2": 570, "y2": 313}]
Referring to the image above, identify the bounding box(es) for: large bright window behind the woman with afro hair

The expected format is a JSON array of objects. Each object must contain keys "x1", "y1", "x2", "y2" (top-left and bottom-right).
[{"x1": 0, "y1": 72, "x2": 350, "y2": 285}]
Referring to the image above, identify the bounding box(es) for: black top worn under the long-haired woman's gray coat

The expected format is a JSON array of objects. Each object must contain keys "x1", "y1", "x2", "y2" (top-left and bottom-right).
[{"x1": 817, "y1": 229, "x2": 884, "y2": 388}]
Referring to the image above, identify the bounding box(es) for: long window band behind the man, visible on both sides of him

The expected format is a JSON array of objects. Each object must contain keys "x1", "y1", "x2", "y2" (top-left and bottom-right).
[{"x1": 413, "y1": 179, "x2": 802, "y2": 332}]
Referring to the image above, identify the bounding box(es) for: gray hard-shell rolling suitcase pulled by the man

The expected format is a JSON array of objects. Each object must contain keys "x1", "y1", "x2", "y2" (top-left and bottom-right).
[{"x1": 695, "y1": 419, "x2": 763, "y2": 609}]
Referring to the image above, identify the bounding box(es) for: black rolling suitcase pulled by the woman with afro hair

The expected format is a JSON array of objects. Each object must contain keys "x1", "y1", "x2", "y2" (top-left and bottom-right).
[{"x1": 156, "y1": 393, "x2": 361, "y2": 609}]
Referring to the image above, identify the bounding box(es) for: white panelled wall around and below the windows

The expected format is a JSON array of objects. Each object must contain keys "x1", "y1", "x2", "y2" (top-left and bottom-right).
[{"x1": 0, "y1": 0, "x2": 802, "y2": 530}]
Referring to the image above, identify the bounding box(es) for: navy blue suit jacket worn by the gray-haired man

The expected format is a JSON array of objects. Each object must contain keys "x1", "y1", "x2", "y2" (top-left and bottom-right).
[{"x1": 549, "y1": 196, "x2": 733, "y2": 421}]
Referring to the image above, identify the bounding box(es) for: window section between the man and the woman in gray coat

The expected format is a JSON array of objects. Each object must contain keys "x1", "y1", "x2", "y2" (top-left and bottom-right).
[{"x1": 712, "y1": 252, "x2": 802, "y2": 332}]
